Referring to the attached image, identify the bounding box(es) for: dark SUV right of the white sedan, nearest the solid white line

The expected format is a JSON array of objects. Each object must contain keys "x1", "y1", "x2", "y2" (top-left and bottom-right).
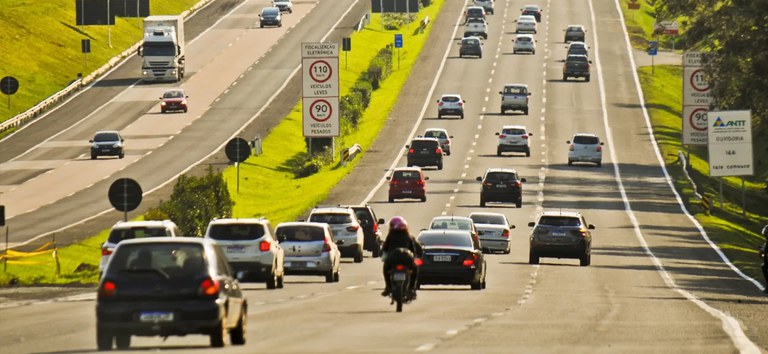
[{"x1": 528, "y1": 211, "x2": 595, "y2": 267}]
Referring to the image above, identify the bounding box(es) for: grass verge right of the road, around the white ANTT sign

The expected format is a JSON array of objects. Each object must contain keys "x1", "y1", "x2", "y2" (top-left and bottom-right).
[{"x1": 639, "y1": 65, "x2": 768, "y2": 279}]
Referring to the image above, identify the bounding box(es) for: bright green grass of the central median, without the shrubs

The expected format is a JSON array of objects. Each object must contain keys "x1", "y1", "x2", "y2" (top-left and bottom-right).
[{"x1": 0, "y1": 0, "x2": 445, "y2": 286}]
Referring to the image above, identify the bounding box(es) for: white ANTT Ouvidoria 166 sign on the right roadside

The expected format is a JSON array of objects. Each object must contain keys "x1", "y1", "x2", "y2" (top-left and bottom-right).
[{"x1": 707, "y1": 111, "x2": 754, "y2": 177}]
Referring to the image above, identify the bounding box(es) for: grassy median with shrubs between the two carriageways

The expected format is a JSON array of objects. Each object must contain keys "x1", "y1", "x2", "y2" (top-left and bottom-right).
[{"x1": 0, "y1": 0, "x2": 445, "y2": 286}]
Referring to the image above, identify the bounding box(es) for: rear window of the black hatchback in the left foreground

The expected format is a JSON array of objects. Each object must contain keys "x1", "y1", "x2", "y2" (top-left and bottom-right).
[{"x1": 107, "y1": 243, "x2": 207, "y2": 278}]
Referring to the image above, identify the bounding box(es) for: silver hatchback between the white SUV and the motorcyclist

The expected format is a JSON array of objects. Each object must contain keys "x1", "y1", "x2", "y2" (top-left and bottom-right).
[{"x1": 275, "y1": 222, "x2": 343, "y2": 283}]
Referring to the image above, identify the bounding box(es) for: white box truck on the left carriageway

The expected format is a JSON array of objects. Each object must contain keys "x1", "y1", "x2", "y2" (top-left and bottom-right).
[{"x1": 139, "y1": 15, "x2": 185, "y2": 82}]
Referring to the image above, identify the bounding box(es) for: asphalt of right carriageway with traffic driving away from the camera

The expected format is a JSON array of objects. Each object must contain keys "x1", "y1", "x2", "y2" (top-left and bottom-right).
[{"x1": 0, "y1": 0, "x2": 768, "y2": 353}]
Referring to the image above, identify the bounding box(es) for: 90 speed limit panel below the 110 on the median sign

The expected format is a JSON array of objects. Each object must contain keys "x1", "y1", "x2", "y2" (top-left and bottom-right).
[{"x1": 302, "y1": 97, "x2": 339, "y2": 138}]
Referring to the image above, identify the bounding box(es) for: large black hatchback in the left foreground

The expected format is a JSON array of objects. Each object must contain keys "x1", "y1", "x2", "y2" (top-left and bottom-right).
[{"x1": 96, "y1": 237, "x2": 247, "y2": 350}]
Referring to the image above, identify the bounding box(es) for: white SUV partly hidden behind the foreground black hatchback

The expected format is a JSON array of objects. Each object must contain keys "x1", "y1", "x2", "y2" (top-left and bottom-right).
[{"x1": 99, "y1": 220, "x2": 179, "y2": 278}]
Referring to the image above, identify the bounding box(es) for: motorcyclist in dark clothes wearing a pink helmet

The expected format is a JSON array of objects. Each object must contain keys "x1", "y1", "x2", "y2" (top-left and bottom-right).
[{"x1": 381, "y1": 216, "x2": 423, "y2": 296}]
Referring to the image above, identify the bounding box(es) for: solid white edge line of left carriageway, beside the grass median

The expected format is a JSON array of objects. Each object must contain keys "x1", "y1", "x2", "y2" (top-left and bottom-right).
[{"x1": 14, "y1": 0, "x2": 360, "y2": 247}]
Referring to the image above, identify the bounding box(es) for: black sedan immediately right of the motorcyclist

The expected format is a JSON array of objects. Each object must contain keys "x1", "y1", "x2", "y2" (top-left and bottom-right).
[{"x1": 416, "y1": 230, "x2": 486, "y2": 290}]
